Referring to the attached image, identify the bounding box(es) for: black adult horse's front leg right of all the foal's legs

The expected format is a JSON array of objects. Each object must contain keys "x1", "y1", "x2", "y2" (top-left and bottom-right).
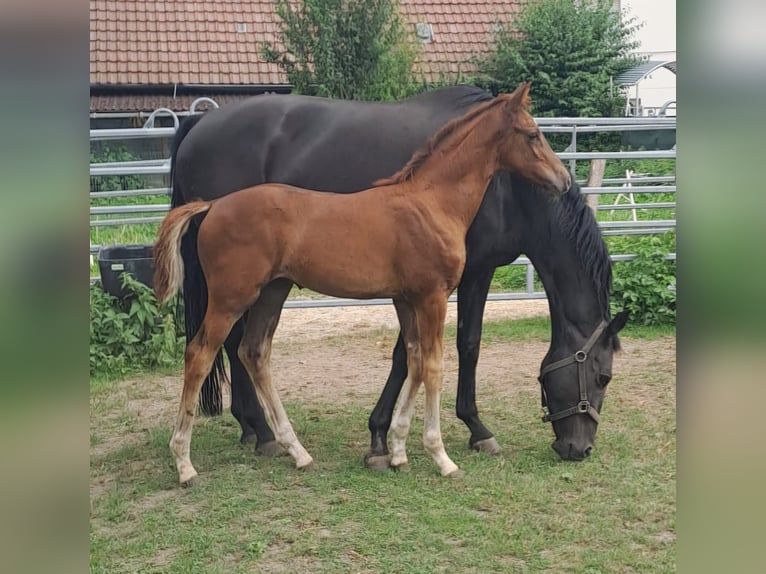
[{"x1": 455, "y1": 269, "x2": 500, "y2": 454}]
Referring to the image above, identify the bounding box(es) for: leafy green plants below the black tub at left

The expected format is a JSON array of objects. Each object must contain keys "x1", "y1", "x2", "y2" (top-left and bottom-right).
[{"x1": 90, "y1": 273, "x2": 185, "y2": 375}]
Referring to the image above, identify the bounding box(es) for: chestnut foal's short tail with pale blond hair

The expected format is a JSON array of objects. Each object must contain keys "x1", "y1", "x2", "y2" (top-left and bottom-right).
[{"x1": 154, "y1": 205, "x2": 211, "y2": 304}]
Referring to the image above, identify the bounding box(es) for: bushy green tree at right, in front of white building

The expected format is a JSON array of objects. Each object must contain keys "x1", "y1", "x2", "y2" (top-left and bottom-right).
[{"x1": 479, "y1": 0, "x2": 639, "y2": 117}]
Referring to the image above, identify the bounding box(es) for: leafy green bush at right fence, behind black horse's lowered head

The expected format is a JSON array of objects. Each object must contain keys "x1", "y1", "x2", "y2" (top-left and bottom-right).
[{"x1": 612, "y1": 235, "x2": 676, "y2": 325}]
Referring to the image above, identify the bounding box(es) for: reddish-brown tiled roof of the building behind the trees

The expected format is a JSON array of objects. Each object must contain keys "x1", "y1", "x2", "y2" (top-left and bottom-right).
[{"x1": 90, "y1": 0, "x2": 525, "y2": 85}]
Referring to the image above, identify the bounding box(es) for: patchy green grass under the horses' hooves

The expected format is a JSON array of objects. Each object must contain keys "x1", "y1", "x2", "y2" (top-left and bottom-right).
[{"x1": 91, "y1": 319, "x2": 675, "y2": 574}]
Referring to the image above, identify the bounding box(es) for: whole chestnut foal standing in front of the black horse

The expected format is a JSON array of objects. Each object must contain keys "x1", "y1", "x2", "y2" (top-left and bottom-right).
[{"x1": 154, "y1": 84, "x2": 571, "y2": 484}]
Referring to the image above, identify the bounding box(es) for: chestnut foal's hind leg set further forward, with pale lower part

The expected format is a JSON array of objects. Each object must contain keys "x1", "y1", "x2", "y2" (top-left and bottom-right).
[{"x1": 238, "y1": 280, "x2": 313, "y2": 469}]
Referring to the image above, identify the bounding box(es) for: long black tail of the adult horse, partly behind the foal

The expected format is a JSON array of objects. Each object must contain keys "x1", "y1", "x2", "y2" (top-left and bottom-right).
[{"x1": 170, "y1": 114, "x2": 226, "y2": 416}]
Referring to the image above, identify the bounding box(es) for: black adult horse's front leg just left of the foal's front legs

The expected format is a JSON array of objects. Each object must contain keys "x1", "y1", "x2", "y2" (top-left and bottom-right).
[{"x1": 364, "y1": 332, "x2": 407, "y2": 470}]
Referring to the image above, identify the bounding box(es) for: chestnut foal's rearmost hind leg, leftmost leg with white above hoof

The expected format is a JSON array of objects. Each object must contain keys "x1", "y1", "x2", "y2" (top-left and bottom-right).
[{"x1": 170, "y1": 307, "x2": 238, "y2": 486}]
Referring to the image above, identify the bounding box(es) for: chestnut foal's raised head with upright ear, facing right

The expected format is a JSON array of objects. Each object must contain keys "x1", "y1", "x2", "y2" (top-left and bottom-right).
[{"x1": 497, "y1": 84, "x2": 572, "y2": 195}]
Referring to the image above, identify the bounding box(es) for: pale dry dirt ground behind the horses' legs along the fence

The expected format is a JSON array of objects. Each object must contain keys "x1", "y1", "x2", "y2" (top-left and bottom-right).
[{"x1": 97, "y1": 300, "x2": 676, "y2": 448}]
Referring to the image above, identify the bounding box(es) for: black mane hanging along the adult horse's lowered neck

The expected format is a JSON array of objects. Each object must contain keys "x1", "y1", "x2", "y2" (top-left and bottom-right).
[{"x1": 554, "y1": 182, "x2": 612, "y2": 328}]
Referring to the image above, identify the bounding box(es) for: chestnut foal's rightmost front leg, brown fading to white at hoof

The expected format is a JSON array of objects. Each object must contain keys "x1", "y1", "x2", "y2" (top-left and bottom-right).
[{"x1": 415, "y1": 293, "x2": 463, "y2": 478}]
